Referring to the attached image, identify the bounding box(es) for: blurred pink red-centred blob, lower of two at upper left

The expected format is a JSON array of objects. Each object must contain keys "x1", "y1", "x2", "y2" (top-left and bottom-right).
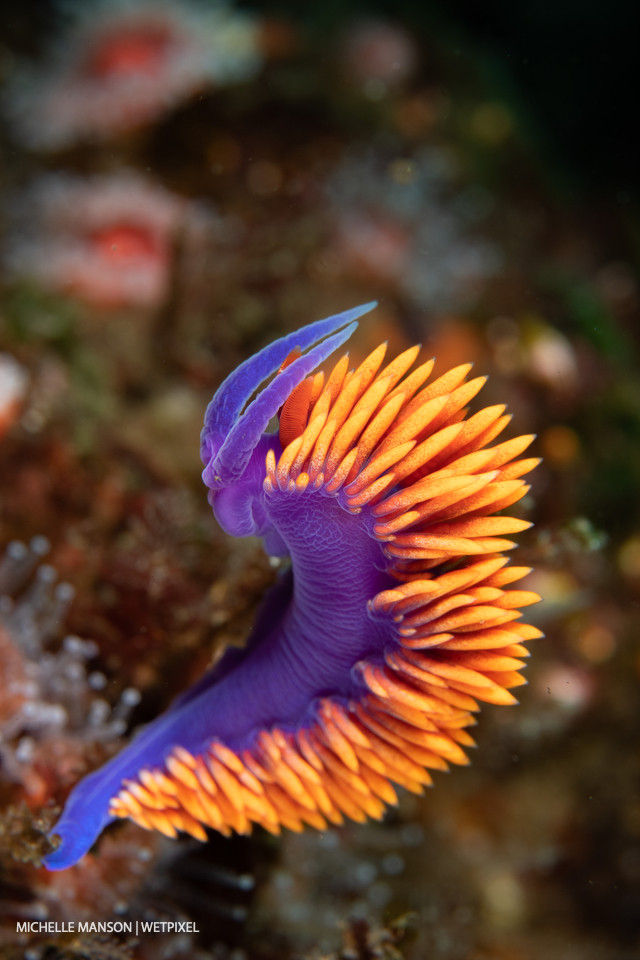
[{"x1": 6, "y1": 171, "x2": 208, "y2": 307}]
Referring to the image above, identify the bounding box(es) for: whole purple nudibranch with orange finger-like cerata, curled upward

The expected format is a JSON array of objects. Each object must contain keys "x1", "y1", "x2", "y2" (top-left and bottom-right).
[{"x1": 45, "y1": 304, "x2": 540, "y2": 870}]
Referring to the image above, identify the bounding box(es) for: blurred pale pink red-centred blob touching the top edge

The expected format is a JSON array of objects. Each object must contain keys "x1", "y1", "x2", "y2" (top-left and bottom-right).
[{"x1": 5, "y1": 0, "x2": 262, "y2": 149}]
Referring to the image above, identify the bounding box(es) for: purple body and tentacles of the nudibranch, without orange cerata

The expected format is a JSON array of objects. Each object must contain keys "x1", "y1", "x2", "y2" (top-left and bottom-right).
[{"x1": 44, "y1": 304, "x2": 395, "y2": 870}]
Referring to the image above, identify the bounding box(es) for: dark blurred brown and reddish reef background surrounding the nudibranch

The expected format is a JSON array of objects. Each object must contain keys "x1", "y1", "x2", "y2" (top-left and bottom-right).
[{"x1": 0, "y1": 0, "x2": 640, "y2": 960}]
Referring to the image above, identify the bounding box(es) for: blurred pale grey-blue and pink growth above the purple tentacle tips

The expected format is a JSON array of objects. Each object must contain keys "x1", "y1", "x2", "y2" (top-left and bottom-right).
[{"x1": 326, "y1": 147, "x2": 501, "y2": 312}]
